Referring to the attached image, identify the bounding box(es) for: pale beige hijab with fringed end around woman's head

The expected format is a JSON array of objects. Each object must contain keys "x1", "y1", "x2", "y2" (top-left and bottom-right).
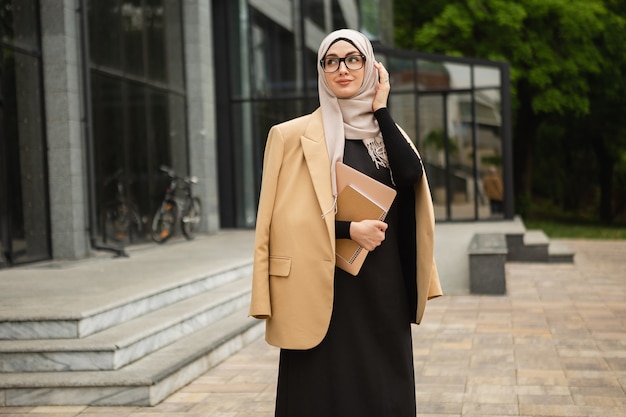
[{"x1": 317, "y1": 29, "x2": 389, "y2": 196}]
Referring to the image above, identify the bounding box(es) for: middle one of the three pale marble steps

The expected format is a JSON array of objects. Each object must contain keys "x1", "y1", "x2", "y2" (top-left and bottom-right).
[{"x1": 0, "y1": 277, "x2": 250, "y2": 373}]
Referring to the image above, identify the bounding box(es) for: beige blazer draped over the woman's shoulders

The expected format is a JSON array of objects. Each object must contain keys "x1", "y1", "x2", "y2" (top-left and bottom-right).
[{"x1": 250, "y1": 109, "x2": 442, "y2": 349}]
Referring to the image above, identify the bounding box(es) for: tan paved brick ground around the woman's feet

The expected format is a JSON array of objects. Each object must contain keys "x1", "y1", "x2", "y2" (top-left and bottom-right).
[{"x1": 0, "y1": 240, "x2": 626, "y2": 417}]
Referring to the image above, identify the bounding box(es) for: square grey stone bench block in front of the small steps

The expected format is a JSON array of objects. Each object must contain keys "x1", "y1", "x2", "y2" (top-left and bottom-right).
[{"x1": 468, "y1": 233, "x2": 508, "y2": 294}]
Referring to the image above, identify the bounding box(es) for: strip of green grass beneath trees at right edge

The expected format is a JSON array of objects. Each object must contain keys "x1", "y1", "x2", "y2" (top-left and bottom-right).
[{"x1": 524, "y1": 219, "x2": 626, "y2": 240}]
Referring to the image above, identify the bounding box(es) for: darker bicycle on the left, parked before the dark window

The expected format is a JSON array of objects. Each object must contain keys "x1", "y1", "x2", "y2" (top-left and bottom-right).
[{"x1": 100, "y1": 169, "x2": 145, "y2": 243}]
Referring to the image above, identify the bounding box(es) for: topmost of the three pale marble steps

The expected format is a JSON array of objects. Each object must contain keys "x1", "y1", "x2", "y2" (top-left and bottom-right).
[{"x1": 0, "y1": 260, "x2": 252, "y2": 340}]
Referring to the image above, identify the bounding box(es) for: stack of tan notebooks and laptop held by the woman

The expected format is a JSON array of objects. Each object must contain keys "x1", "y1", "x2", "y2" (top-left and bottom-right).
[{"x1": 335, "y1": 162, "x2": 396, "y2": 275}]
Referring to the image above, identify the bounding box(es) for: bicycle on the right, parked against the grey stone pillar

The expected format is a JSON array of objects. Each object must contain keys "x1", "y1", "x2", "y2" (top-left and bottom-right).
[{"x1": 152, "y1": 165, "x2": 202, "y2": 243}]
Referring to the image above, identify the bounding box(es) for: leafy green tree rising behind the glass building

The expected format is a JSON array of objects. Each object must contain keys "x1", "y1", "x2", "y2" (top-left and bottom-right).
[{"x1": 394, "y1": 0, "x2": 625, "y2": 221}]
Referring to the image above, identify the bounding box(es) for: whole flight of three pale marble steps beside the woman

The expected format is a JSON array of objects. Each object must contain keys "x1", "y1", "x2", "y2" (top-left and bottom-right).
[{"x1": 0, "y1": 231, "x2": 263, "y2": 406}]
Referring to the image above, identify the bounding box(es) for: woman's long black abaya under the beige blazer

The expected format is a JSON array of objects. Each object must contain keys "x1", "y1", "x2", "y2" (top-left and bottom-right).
[{"x1": 276, "y1": 140, "x2": 421, "y2": 417}]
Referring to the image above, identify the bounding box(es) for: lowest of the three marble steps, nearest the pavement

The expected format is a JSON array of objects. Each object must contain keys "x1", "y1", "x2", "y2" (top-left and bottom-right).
[{"x1": 0, "y1": 307, "x2": 264, "y2": 406}]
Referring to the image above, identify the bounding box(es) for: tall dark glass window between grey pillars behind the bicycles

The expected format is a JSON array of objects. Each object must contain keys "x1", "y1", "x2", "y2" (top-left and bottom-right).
[{"x1": 90, "y1": 0, "x2": 188, "y2": 242}]
